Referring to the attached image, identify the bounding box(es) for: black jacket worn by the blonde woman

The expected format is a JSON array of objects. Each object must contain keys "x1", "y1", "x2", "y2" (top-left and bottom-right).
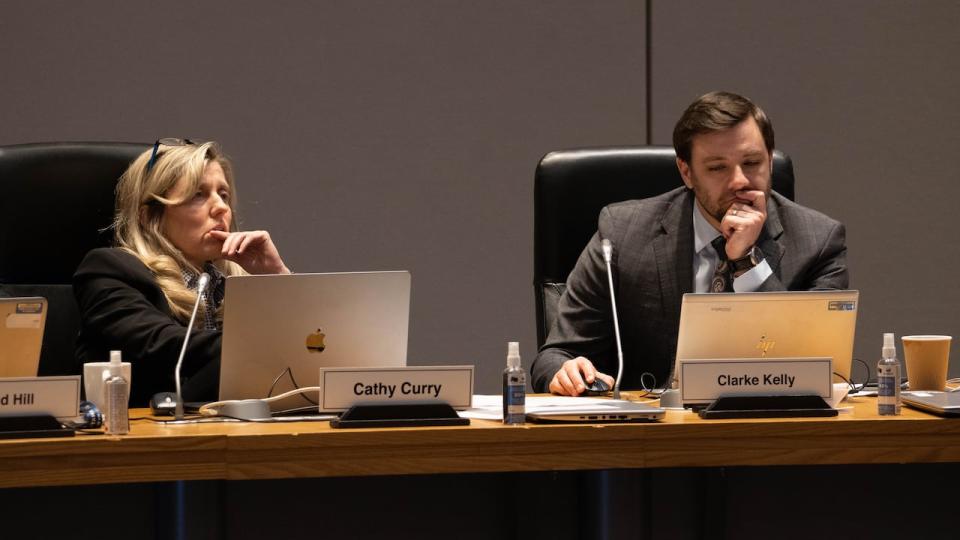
[{"x1": 73, "y1": 248, "x2": 222, "y2": 407}]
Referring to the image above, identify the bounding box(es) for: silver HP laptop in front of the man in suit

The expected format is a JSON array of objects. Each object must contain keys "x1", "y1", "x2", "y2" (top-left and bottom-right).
[{"x1": 677, "y1": 291, "x2": 860, "y2": 384}]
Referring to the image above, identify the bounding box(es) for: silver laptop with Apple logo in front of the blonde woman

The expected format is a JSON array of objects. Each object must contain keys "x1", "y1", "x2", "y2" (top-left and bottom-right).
[{"x1": 220, "y1": 272, "x2": 410, "y2": 411}]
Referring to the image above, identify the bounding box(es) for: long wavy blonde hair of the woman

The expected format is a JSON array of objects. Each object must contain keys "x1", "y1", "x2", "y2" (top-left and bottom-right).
[{"x1": 113, "y1": 142, "x2": 246, "y2": 322}]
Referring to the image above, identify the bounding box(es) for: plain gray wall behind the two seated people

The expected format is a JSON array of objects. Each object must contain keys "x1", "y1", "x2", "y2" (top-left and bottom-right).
[{"x1": 0, "y1": 0, "x2": 960, "y2": 393}]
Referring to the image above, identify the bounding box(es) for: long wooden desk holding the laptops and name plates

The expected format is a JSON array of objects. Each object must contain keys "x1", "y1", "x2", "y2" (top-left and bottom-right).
[{"x1": 0, "y1": 398, "x2": 960, "y2": 487}]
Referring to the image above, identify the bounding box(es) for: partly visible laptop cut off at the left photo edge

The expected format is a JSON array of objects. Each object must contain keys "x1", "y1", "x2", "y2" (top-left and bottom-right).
[{"x1": 0, "y1": 297, "x2": 47, "y2": 377}]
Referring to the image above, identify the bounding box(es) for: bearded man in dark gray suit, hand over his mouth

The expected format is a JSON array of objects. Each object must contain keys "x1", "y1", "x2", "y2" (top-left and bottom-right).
[{"x1": 531, "y1": 92, "x2": 848, "y2": 396}]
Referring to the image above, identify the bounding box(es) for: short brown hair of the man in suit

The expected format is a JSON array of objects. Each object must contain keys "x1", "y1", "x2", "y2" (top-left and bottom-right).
[{"x1": 673, "y1": 92, "x2": 773, "y2": 163}]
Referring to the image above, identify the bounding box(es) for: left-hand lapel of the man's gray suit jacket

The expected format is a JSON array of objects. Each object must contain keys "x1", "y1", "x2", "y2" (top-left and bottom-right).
[{"x1": 653, "y1": 190, "x2": 693, "y2": 320}]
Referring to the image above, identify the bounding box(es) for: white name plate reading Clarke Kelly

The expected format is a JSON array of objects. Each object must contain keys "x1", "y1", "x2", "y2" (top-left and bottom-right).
[{"x1": 680, "y1": 358, "x2": 833, "y2": 405}]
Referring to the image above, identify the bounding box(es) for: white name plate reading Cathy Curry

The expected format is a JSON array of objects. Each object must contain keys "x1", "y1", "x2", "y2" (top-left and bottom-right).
[{"x1": 320, "y1": 366, "x2": 473, "y2": 412}]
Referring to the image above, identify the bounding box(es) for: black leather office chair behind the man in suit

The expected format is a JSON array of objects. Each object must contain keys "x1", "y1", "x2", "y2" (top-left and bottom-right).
[{"x1": 533, "y1": 146, "x2": 794, "y2": 347}]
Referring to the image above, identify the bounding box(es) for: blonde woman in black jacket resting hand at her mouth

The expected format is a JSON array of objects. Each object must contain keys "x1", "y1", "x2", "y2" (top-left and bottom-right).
[{"x1": 73, "y1": 139, "x2": 290, "y2": 406}]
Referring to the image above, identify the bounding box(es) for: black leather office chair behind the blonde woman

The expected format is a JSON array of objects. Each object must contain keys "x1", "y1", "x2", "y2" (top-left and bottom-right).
[{"x1": 0, "y1": 143, "x2": 149, "y2": 375}]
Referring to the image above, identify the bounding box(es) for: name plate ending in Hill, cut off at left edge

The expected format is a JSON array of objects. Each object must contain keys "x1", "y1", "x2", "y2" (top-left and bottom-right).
[{"x1": 0, "y1": 375, "x2": 80, "y2": 418}]
